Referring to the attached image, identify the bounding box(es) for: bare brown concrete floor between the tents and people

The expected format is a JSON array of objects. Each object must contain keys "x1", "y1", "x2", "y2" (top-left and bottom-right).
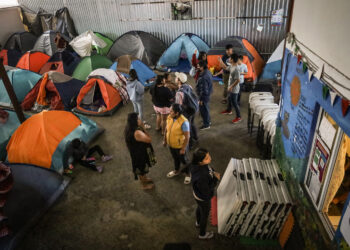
[{"x1": 19, "y1": 77, "x2": 282, "y2": 250}]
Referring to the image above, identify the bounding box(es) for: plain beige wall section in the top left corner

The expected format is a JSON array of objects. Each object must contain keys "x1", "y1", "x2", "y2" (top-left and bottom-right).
[{"x1": 0, "y1": 7, "x2": 24, "y2": 46}]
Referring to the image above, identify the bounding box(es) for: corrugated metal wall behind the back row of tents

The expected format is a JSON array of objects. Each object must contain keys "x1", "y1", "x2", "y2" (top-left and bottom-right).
[{"x1": 19, "y1": 0, "x2": 289, "y2": 58}]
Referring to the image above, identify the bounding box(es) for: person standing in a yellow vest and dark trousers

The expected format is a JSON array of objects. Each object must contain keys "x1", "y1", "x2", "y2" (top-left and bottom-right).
[{"x1": 163, "y1": 103, "x2": 191, "y2": 184}]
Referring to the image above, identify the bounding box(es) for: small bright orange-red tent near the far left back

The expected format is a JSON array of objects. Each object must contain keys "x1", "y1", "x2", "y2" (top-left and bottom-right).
[{"x1": 16, "y1": 51, "x2": 50, "y2": 73}]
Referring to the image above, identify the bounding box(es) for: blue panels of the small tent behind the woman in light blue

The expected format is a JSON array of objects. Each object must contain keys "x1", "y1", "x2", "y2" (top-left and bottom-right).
[{"x1": 110, "y1": 60, "x2": 157, "y2": 87}]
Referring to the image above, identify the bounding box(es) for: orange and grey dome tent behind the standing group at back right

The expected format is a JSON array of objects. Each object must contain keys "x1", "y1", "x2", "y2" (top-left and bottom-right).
[{"x1": 207, "y1": 36, "x2": 265, "y2": 82}]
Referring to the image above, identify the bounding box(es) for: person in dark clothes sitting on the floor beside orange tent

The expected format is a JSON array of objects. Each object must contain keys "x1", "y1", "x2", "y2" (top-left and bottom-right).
[{"x1": 66, "y1": 138, "x2": 113, "y2": 173}]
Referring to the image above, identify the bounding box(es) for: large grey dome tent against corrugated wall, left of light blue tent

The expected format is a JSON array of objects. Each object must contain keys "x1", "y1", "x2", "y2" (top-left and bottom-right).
[{"x1": 108, "y1": 31, "x2": 166, "y2": 66}]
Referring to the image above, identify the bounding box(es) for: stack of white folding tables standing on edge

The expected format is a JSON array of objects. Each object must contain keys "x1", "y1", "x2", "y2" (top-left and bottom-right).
[{"x1": 217, "y1": 158, "x2": 292, "y2": 239}]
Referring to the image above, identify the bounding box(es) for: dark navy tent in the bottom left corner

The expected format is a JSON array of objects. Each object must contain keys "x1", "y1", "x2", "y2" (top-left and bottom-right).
[{"x1": 0, "y1": 164, "x2": 69, "y2": 250}]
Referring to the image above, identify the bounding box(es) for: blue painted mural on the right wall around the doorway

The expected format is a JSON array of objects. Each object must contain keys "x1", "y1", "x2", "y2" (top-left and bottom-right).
[{"x1": 274, "y1": 49, "x2": 350, "y2": 249}]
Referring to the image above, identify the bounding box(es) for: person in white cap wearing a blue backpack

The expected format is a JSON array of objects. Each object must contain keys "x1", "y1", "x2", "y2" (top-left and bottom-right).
[{"x1": 175, "y1": 72, "x2": 198, "y2": 149}]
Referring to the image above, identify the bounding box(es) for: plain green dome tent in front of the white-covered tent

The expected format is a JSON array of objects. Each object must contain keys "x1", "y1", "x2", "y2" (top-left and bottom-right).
[{"x1": 72, "y1": 55, "x2": 113, "y2": 81}]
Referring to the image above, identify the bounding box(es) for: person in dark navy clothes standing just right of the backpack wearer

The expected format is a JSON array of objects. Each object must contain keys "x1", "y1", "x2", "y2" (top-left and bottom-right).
[{"x1": 196, "y1": 61, "x2": 213, "y2": 130}]
